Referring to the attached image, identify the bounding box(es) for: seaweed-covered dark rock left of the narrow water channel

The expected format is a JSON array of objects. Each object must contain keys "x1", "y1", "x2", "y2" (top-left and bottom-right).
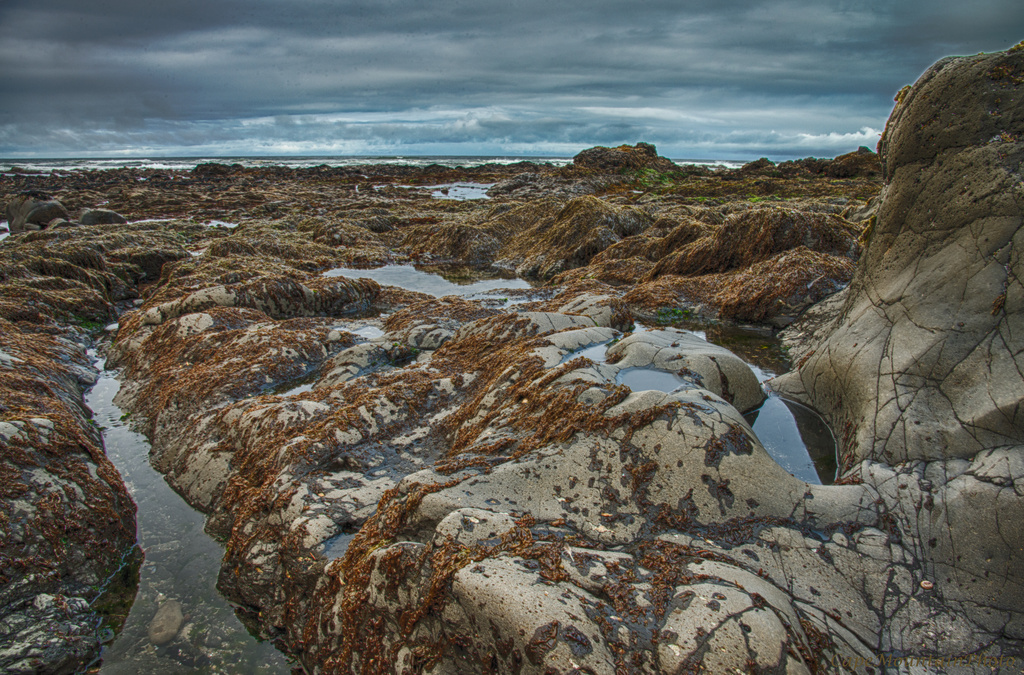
[{"x1": 0, "y1": 320, "x2": 135, "y2": 672}]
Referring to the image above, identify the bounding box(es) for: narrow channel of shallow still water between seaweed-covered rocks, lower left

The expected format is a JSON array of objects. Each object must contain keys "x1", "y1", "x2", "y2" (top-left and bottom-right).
[{"x1": 85, "y1": 352, "x2": 293, "y2": 675}]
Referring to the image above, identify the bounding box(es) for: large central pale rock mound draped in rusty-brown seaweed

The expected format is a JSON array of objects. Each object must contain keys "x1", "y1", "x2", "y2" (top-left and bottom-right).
[{"x1": 110, "y1": 272, "x2": 891, "y2": 672}]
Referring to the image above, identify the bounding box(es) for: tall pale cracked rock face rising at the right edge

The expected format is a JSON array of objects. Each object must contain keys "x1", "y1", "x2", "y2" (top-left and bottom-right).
[{"x1": 777, "y1": 50, "x2": 1024, "y2": 645}]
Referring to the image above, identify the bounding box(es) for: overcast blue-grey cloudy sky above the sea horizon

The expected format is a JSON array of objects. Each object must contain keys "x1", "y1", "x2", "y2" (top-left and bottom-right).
[{"x1": 0, "y1": 0, "x2": 1024, "y2": 160}]
